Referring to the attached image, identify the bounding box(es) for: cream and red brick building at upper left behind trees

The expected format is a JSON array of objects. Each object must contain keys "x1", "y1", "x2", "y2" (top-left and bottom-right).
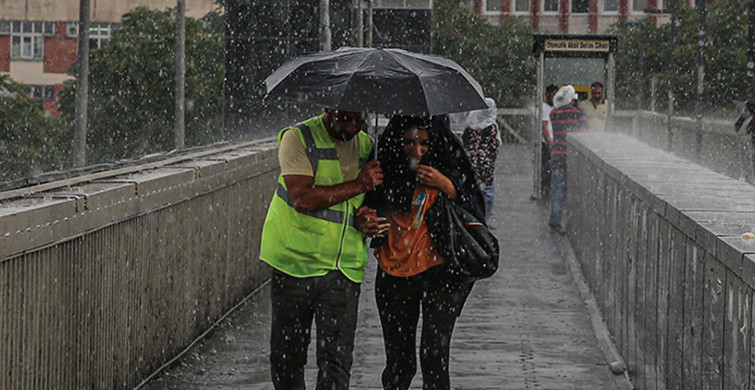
[{"x1": 0, "y1": 0, "x2": 216, "y2": 116}]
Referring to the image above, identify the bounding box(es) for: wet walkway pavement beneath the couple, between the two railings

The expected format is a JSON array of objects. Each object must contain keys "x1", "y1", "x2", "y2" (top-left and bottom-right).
[{"x1": 142, "y1": 145, "x2": 632, "y2": 390}]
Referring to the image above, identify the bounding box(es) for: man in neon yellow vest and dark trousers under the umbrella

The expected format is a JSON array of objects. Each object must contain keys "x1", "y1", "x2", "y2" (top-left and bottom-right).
[{"x1": 260, "y1": 109, "x2": 387, "y2": 390}]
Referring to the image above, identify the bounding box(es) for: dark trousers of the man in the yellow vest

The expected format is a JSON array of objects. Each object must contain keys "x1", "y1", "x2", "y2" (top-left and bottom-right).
[{"x1": 270, "y1": 270, "x2": 360, "y2": 390}]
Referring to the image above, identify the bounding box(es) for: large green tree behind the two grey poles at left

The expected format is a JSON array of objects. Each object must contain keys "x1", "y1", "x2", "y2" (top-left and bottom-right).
[{"x1": 61, "y1": 8, "x2": 224, "y2": 163}]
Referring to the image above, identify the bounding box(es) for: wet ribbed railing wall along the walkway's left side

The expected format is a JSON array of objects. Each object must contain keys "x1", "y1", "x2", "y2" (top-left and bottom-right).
[{"x1": 0, "y1": 139, "x2": 278, "y2": 389}]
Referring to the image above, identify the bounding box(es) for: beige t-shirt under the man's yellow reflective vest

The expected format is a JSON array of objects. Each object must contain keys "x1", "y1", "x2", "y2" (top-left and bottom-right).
[{"x1": 278, "y1": 128, "x2": 360, "y2": 182}]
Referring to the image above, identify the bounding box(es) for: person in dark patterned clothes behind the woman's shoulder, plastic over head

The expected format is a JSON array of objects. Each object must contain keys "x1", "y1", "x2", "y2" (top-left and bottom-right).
[{"x1": 461, "y1": 98, "x2": 501, "y2": 223}]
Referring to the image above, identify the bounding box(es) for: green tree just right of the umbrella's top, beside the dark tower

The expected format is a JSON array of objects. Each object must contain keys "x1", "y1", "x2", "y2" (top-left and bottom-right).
[{"x1": 432, "y1": 0, "x2": 536, "y2": 107}]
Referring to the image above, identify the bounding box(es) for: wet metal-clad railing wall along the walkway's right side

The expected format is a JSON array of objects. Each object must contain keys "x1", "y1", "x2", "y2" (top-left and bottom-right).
[{"x1": 566, "y1": 134, "x2": 755, "y2": 389}]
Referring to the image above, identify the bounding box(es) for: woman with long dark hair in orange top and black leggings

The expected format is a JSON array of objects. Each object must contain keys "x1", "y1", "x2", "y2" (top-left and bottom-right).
[{"x1": 366, "y1": 116, "x2": 483, "y2": 389}]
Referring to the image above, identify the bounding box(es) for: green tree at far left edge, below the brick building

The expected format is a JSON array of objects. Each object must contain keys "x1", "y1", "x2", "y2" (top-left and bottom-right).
[{"x1": 0, "y1": 75, "x2": 71, "y2": 181}]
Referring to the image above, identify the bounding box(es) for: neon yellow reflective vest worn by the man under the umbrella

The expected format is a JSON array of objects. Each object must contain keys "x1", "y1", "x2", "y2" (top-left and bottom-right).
[{"x1": 260, "y1": 115, "x2": 372, "y2": 283}]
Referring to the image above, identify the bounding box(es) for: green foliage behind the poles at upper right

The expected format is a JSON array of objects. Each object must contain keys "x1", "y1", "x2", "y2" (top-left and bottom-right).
[{"x1": 613, "y1": 0, "x2": 747, "y2": 115}]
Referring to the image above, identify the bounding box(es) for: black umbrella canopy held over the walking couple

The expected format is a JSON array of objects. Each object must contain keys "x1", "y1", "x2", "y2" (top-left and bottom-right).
[{"x1": 265, "y1": 47, "x2": 488, "y2": 115}]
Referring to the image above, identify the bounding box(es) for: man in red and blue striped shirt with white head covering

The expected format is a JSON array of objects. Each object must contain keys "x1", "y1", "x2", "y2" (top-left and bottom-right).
[{"x1": 548, "y1": 85, "x2": 587, "y2": 233}]
